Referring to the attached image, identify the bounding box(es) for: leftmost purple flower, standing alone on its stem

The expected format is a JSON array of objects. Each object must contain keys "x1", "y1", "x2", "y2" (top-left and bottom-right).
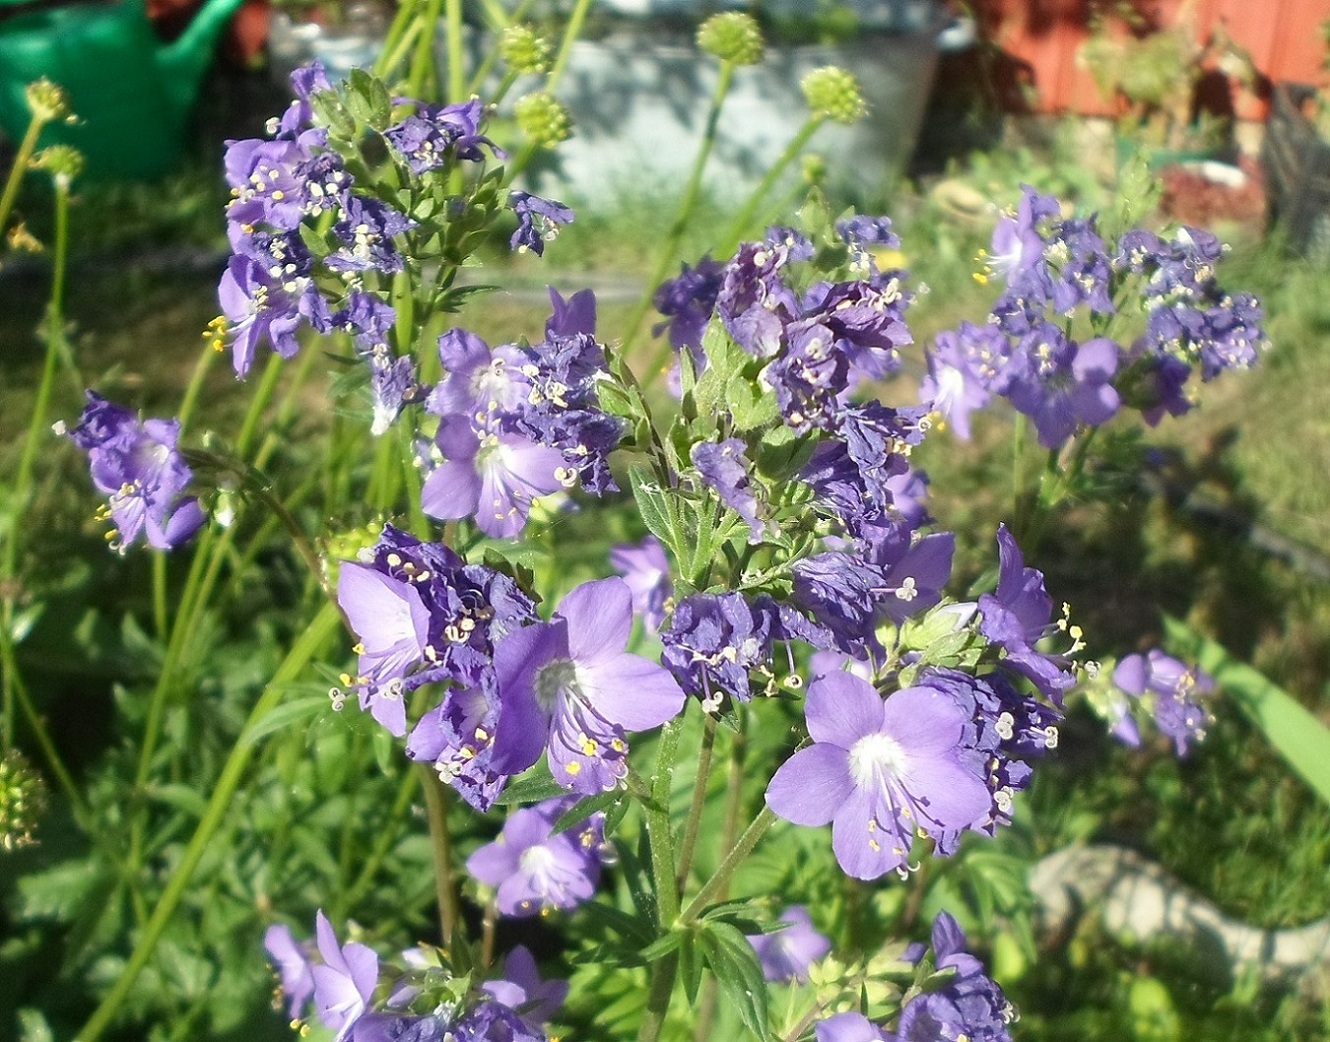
[{"x1": 69, "y1": 391, "x2": 205, "y2": 552}]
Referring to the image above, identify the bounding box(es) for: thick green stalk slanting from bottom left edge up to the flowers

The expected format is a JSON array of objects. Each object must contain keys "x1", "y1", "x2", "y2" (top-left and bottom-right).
[{"x1": 77, "y1": 604, "x2": 340, "y2": 1042}]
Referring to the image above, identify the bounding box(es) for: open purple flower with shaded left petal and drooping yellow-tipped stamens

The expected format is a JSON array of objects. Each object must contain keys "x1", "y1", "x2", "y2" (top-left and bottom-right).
[{"x1": 493, "y1": 576, "x2": 684, "y2": 794}]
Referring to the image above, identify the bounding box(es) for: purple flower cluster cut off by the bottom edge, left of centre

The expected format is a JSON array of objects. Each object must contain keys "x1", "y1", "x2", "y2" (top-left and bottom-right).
[{"x1": 263, "y1": 912, "x2": 567, "y2": 1042}]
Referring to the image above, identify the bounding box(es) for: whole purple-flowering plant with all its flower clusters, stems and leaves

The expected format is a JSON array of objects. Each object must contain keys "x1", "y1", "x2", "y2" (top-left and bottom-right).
[{"x1": 15, "y1": 10, "x2": 1262, "y2": 1042}]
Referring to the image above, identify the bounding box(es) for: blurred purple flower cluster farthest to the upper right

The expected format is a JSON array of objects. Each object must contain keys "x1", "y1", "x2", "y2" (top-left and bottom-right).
[{"x1": 920, "y1": 185, "x2": 1264, "y2": 448}]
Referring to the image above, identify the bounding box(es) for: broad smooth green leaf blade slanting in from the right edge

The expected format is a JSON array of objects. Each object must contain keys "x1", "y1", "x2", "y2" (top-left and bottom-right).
[{"x1": 1164, "y1": 617, "x2": 1330, "y2": 804}]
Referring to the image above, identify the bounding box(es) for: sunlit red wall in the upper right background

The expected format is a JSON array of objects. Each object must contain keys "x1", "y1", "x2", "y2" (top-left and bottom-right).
[{"x1": 976, "y1": 0, "x2": 1330, "y2": 118}]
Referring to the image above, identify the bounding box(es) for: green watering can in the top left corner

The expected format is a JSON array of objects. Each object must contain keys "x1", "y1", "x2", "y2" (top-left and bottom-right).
[{"x1": 0, "y1": 0, "x2": 243, "y2": 180}]
